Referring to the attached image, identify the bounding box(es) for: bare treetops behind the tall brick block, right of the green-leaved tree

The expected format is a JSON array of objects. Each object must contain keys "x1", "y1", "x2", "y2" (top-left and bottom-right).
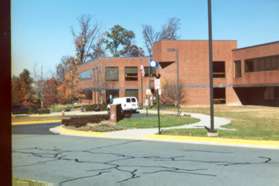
[{"x1": 142, "y1": 17, "x2": 180, "y2": 56}]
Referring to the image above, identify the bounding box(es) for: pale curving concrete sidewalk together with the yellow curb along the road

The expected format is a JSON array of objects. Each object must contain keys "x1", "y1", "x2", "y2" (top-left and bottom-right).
[{"x1": 50, "y1": 111, "x2": 279, "y2": 149}]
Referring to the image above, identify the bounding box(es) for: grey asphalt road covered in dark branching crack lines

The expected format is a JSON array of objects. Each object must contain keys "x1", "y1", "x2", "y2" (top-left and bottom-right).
[{"x1": 12, "y1": 132, "x2": 279, "y2": 186}]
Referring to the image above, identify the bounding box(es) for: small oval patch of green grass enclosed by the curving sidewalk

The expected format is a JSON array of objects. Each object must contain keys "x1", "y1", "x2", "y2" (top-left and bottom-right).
[{"x1": 117, "y1": 114, "x2": 199, "y2": 128}]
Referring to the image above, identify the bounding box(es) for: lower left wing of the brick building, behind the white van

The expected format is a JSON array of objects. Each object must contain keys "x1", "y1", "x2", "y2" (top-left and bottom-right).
[{"x1": 78, "y1": 57, "x2": 150, "y2": 103}]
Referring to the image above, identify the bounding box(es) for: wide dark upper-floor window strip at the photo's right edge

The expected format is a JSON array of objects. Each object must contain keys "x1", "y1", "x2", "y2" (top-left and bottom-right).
[{"x1": 245, "y1": 55, "x2": 279, "y2": 72}]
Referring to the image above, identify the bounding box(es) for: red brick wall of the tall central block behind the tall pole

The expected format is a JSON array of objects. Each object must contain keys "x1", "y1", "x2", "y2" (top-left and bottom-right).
[{"x1": 153, "y1": 40, "x2": 239, "y2": 105}]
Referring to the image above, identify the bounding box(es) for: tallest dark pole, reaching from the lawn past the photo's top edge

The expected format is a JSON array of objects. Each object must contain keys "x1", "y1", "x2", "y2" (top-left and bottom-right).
[{"x1": 208, "y1": 0, "x2": 216, "y2": 133}]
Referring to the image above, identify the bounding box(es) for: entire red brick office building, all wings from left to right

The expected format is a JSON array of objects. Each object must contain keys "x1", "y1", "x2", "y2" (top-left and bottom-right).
[{"x1": 77, "y1": 40, "x2": 279, "y2": 106}]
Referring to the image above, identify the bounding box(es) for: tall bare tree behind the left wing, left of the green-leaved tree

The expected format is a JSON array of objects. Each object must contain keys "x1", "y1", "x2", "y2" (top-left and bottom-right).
[{"x1": 72, "y1": 15, "x2": 103, "y2": 64}]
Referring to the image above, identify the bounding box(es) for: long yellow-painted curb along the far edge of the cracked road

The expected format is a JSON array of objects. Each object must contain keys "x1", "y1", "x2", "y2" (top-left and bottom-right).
[{"x1": 50, "y1": 126, "x2": 279, "y2": 149}]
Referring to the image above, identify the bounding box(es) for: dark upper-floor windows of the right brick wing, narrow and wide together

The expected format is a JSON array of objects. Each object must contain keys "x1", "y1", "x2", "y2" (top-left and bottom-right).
[{"x1": 234, "y1": 55, "x2": 279, "y2": 78}]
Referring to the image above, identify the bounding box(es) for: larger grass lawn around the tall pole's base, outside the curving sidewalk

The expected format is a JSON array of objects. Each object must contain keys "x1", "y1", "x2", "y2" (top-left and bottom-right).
[{"x1": 163, "y1": 105, "x2": 279, "y2": 140}]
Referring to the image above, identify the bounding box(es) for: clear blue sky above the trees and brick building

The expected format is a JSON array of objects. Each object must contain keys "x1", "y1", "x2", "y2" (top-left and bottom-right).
[{"x1": 11, "y1": 0, "x2": 279, "y2": 77}]
